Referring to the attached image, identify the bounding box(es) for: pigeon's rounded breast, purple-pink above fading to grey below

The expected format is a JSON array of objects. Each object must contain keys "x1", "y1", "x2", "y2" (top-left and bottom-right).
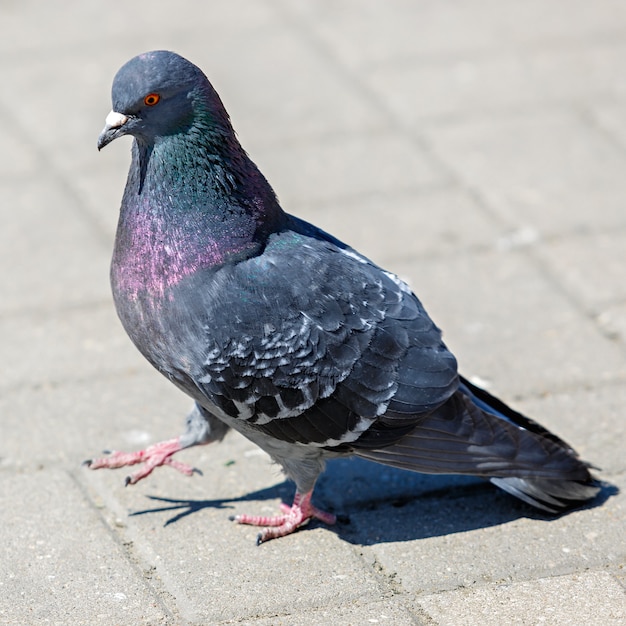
[{"x1": 111, "y1": 197, "x2": 260, "y2": 389}]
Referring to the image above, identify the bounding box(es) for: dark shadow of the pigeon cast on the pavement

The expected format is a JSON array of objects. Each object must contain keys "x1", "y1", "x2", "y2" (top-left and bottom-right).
[{"x1": 131, "y1": 459, "x2": 619, "y2": 545}]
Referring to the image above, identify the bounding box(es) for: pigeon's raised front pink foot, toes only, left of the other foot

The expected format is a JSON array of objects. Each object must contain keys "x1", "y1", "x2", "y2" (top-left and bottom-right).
[{"x1": 84, "y1": 437, "x2": 200, "y2": 485}]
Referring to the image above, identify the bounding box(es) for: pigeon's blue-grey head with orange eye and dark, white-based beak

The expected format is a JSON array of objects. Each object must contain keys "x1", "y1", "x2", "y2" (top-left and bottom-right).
[{"x1": 98, "y1": 50, "x2": 232, "y2": 150}]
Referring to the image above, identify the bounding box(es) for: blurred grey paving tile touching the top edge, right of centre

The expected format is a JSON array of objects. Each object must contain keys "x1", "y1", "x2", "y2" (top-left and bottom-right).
[{"x1": 282, "y1": 0, "x2": 624, "y2": 69}]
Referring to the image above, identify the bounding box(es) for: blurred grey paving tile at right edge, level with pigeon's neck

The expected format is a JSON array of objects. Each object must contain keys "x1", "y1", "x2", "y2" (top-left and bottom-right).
[{"x1": 428, "y1": 112, "x2": 626, "y2": 234}]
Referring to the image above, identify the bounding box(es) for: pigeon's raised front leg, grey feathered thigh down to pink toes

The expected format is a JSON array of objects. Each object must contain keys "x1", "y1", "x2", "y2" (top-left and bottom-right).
[{"x1": 84, "y1": 404, "x2": 228, "y2": 485}]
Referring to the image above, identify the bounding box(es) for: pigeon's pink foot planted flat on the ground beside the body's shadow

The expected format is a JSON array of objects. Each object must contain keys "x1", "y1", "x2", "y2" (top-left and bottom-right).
[{"x1": 230, "y1": 490, "x2": 337, "y2": 545}]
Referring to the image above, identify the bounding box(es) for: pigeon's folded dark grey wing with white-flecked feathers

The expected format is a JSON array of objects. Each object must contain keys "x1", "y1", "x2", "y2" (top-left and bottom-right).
[{"x1": 195, "y1": 225, "x2": 458, "y2": 446}]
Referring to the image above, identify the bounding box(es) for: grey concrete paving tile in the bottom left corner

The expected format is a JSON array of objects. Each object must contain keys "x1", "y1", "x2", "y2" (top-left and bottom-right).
[{"x1": 0, "y1": 470, "x2": 174, "y2": 625}]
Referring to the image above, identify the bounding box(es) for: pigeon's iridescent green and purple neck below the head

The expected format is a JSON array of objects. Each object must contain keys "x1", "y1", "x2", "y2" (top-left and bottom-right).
[{"x1": 111, "y1": 137, "x2": 282, "y2": 302}]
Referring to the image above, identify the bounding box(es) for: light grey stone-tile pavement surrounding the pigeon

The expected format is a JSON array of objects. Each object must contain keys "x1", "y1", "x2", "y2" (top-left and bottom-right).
[{"x1": 0, "y1": 0, "x2": 626, "y2": 626}]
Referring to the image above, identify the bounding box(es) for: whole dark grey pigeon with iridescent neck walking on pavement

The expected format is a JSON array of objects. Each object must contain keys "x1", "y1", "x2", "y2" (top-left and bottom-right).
[{"x1": 85, "y1": 50, "x2": 599, "y2": 543}]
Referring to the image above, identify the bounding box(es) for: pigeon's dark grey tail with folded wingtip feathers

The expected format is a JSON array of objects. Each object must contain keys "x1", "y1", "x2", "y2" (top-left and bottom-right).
[{"x1": 354, "y1": 379, "x2": 599, "y2": 513}]
